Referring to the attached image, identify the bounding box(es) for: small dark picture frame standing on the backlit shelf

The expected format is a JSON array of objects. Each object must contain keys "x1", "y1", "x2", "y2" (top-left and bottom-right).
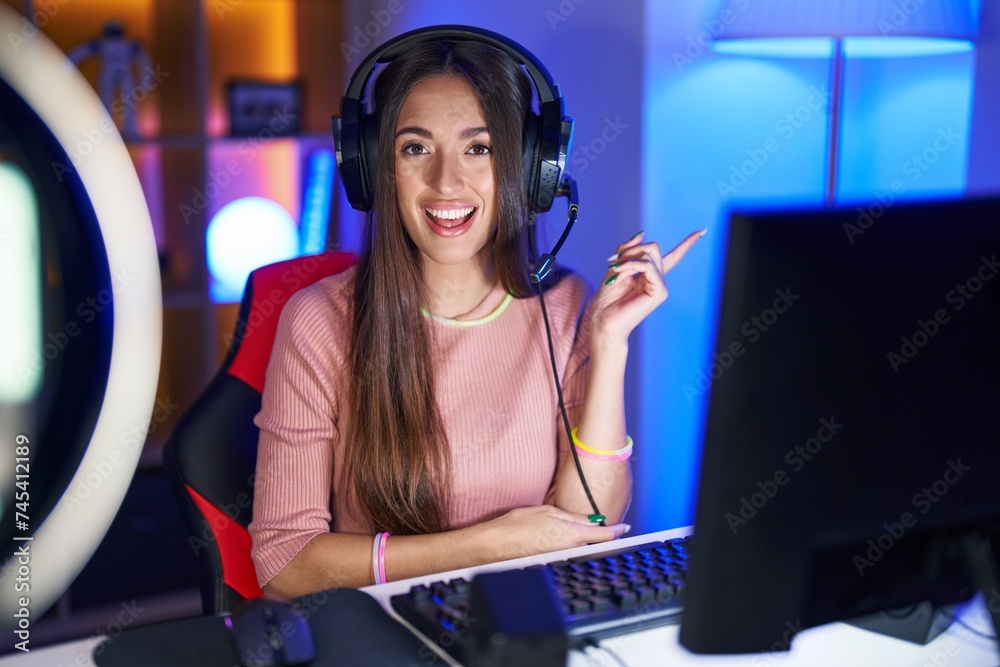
[{"x1": 227, "y1": 80, "x2": 302, "y2": 137}]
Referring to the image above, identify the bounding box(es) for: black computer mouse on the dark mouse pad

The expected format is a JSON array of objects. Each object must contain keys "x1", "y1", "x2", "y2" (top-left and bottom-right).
[{"x1": 225, "y1": 598, "x2": 316, "y2": 667}]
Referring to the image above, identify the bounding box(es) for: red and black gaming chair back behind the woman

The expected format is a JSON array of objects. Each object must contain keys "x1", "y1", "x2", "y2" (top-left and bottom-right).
[{"x1": 163, "y1": 252, "x2": 355, "y2": 614}]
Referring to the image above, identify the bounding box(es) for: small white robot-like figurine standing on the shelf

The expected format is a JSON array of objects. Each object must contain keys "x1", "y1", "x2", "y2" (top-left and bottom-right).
[{"x1": 69, "y1": 21, "x2": 151, "y2": 138}]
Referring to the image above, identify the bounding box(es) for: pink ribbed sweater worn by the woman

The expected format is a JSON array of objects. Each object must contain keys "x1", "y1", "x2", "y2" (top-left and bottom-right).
[{"x1": 250, "y1": 268, "x2": 591, "y2": 585}]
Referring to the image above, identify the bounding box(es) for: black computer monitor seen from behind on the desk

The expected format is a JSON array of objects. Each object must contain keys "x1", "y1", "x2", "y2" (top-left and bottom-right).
[{"x1": 680, "y1": 199, "x2": 1000, "y2": 653}]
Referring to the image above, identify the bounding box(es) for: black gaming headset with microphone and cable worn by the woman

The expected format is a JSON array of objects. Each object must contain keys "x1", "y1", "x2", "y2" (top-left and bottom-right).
[{"x1": 333, "y1": 25, "x2": 604, "y2": 526}]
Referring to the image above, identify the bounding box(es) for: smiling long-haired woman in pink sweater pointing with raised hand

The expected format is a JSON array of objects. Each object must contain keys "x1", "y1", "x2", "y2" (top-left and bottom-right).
[{"x1": 250, "y1": 41, "x2": 698, "y2": 597}]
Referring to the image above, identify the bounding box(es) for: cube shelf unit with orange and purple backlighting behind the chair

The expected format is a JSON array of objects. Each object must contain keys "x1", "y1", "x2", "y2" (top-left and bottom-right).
[{"x1": 0, "y1": 0, "x2": 348, "y2": 641}]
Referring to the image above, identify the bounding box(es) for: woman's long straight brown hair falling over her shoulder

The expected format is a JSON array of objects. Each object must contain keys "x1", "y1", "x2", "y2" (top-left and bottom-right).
[{"x1": 342, "y1": 41, "x2": 532, "y2": 535}]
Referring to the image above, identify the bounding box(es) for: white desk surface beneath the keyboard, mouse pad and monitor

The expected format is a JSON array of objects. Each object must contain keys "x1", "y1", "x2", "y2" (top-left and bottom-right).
[{"x1": 0, "y1": 528, "x2": 1000, "y2": 667}]
